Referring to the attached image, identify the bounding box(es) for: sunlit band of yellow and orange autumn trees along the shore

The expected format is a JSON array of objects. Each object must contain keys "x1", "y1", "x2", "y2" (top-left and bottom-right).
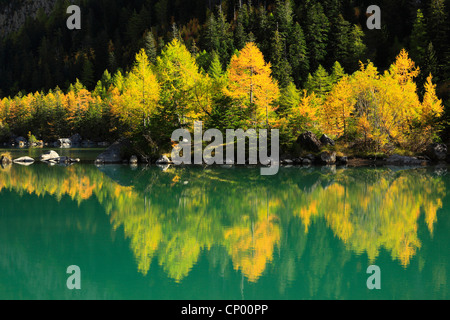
[{"x1": 0, "y1": 38, "x2": 444, "y2": 152}]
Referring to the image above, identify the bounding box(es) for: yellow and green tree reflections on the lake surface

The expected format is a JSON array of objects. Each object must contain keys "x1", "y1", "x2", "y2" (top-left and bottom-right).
[{"x1": 0, "y1": 164, "x2": 446, "y2": 284}]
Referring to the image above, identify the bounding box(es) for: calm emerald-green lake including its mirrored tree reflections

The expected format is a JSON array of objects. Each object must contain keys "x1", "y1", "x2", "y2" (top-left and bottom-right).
[{"x1": 0, "y1": 149, "x2": 450, "y2": 300}]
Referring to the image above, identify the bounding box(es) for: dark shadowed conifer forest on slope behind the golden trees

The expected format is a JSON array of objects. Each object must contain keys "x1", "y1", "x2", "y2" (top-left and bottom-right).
[{"x1": 0, "y1": 0, "x2": 450, "y2": 100}]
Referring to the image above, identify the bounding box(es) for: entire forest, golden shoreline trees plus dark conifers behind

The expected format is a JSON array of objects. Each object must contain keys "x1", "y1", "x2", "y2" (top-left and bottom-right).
[{"x1": 0, "y1": 0, "x2": 450, "y2": 158}]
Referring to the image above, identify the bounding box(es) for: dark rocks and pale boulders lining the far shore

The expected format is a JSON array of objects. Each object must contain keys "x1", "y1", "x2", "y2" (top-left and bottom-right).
[{"x1": 0, "y1": 131, "x2": 450, "y2": 167}]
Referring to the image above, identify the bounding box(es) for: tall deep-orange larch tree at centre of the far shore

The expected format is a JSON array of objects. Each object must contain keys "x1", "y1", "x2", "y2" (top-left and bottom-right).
[{"x1": 224, "y1": 42, "x2": 280, "y2": 127}]
